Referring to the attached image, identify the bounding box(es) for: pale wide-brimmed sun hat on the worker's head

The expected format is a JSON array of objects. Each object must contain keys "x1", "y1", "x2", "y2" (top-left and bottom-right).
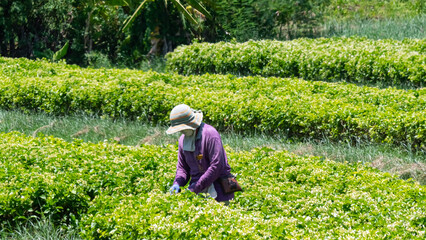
[{"x1": 166, "y1": 104, "x2": 203, "y2": 134}]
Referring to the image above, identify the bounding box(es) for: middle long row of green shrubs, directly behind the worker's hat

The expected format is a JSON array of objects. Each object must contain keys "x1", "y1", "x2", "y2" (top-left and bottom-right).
[{"x1": 0, "y1": 59, "x2": 426, "y2": 150}]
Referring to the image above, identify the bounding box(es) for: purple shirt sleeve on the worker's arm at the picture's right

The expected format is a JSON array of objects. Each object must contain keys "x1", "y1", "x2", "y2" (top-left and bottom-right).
[{"x1": 194, "y1": 138, "x2": 226, "y2": 193}]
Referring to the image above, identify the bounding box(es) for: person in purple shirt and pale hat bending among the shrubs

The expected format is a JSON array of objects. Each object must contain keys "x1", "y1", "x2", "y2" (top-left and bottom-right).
[{"x1": 166, "y1": 104, "x2": 234, "y2": 204}]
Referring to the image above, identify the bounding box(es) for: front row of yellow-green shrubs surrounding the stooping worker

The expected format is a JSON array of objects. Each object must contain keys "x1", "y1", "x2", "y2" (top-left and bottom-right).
[{"x1": 0, "y1": 133, "x2": 426, "y2": 239}]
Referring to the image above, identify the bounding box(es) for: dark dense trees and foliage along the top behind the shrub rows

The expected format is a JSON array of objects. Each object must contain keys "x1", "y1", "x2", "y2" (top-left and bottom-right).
[{"x1": 0, "y1": 0, "x2": 426, "y2": 67}]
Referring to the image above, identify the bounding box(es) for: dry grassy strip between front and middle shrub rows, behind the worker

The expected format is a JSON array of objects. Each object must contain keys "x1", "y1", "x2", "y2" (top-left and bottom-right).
[{"x1": 0, "y1": 110, "x2": 426, "y2": 184}]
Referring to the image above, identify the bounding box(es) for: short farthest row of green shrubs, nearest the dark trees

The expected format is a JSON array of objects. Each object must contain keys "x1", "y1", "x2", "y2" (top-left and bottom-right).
[{"x1": 166, "y1": 38, "x2": 426, "y2": 87}]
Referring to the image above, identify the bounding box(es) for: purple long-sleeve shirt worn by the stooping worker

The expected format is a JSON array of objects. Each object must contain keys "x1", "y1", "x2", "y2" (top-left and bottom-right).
[{"x1": 174, "y1": 123, "x2": 234, "y2": 202}]
